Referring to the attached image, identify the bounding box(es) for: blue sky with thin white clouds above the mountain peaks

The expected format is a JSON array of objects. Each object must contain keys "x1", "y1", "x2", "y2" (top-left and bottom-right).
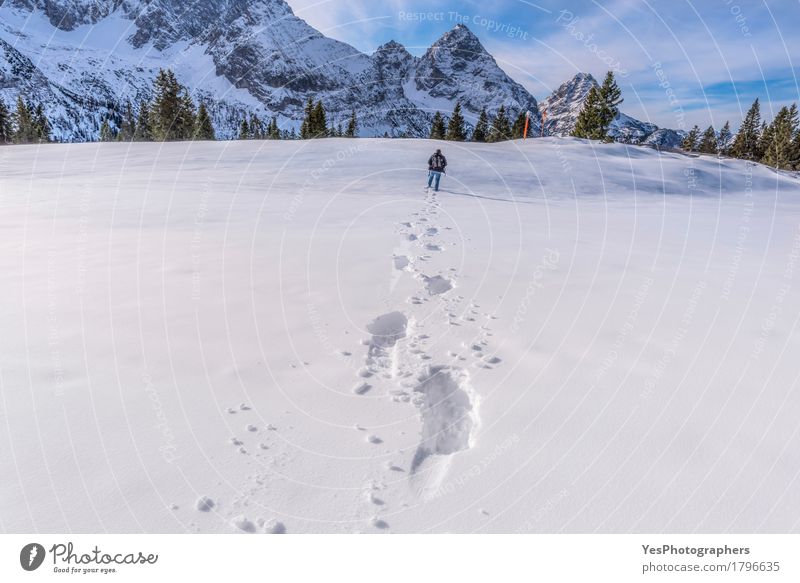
[{"x1": 288, "y1": 0, "x2": 800, "y2": 128}]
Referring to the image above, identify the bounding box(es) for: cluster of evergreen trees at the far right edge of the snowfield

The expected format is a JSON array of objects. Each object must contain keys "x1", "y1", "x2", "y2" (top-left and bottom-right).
[{"x1": 681, "y1": 99, "x2": 800, "y2": 170}]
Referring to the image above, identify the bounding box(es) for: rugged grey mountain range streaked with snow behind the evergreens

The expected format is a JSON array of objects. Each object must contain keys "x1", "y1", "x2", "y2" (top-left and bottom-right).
[{"x1": 0, "y1": 0, "x2": 668, "y2": 142}]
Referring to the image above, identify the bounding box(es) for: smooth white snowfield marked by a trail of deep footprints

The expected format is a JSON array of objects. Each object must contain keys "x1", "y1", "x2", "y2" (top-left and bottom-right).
[{"x1": 0, "y1": 138, "x2": 800, "y2": 533}]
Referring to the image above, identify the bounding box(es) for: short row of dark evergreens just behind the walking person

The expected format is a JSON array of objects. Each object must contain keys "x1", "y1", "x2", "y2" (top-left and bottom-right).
[{"x1": 428, "y1": 102, "x2": 527, "y2": 143}]
